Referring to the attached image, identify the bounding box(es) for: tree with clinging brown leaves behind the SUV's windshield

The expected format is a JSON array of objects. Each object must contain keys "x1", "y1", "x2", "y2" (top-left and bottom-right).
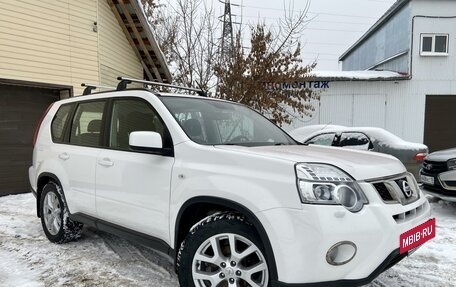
[{"x1": 215, "y1": 3, "x2": 319, "y2": 125}]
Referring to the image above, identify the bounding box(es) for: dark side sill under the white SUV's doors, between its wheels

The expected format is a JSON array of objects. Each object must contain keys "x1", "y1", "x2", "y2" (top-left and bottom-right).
[{"x1": 70, "y1": 213, "x2": 176, "y2": 261}]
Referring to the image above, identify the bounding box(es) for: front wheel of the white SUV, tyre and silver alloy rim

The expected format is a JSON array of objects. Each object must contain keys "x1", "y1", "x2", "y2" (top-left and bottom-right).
[{"x1": 176, "y1": 213, "x2": 270, "y2": 287}]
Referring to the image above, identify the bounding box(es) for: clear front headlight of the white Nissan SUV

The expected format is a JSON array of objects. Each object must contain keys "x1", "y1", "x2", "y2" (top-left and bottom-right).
[{"x1": 296, "y1": 163, "x2": 368, "y2": 212}]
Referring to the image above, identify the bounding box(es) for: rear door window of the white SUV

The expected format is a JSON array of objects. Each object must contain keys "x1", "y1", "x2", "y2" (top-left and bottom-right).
[{"x1": 70, "y1": 101, "x2": 105, "y2": 146}]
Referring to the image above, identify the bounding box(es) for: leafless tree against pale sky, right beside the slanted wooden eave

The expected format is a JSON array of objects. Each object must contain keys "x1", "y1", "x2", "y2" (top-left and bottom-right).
[{"x1": 142, "y1": 0, "x2": 219, "y2": 90}]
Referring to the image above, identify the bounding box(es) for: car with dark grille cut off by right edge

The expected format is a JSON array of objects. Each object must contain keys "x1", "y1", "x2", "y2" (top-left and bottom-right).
[{"x1": 421, "y1": 148, "x2": 456, "y2": 201}]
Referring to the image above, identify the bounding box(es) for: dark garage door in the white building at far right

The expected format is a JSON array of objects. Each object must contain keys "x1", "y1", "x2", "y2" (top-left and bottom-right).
[{"x1": 424, "y1": 95, "x2": 456, "y2": 151}]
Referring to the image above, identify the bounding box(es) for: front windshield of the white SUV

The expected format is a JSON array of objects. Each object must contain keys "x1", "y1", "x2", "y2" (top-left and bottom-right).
[{"x1": 160, "y1": 96, "x2": 296, "y2": 146}]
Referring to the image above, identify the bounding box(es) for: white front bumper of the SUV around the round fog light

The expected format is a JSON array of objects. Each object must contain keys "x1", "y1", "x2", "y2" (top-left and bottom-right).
[{"x1": 257, "y1": 183, "x2": 431, "y2": 286}]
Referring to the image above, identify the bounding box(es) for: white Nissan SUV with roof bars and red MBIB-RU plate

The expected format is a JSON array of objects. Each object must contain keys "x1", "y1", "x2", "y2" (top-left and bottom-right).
[{"x1": 29, "y1": 79, "x2": 435, "y2": 287}]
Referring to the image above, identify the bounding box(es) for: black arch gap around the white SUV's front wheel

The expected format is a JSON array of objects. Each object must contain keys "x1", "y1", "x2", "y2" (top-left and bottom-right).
[{"x1": 174, "y1": 196, "x2": 278, "y2": 281}]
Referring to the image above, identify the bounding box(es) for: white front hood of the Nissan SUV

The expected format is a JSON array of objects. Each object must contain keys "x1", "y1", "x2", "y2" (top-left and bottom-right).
[{"x1": 216, "y1": 145, "x2": 406, "y2": 180}]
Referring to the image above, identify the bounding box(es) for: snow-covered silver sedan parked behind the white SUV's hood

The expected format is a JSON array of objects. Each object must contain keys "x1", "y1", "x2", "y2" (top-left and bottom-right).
[{"x1": 289, "y1": 126, "x2": 428, "y2": 180}]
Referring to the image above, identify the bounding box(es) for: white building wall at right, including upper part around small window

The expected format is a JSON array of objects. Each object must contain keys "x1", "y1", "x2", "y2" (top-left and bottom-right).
[{"x1": 284, "y1": 0, "x2": 456, "y2": 146}]
